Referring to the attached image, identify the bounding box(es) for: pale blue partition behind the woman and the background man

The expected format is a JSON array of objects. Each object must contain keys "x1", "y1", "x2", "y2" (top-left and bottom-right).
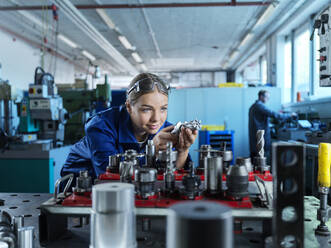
[{"x1": 168, "y1": 87, "x2": 281, "y2": 165}]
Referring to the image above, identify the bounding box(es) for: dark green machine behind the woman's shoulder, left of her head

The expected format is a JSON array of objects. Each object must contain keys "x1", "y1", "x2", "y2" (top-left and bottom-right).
[{"x1": 58, "y1": 75, "x2": 111, "y2": 144}]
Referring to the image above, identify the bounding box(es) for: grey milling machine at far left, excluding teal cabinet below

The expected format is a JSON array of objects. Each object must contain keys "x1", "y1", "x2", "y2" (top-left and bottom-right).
[{"x1": 0, "y1": 67, "x2": 68, "y2": 149}]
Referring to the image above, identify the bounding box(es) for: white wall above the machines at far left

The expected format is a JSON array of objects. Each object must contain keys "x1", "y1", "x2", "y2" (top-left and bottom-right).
[{"x1": 0, "y1": 31, "x2": 75, "y2": 95}]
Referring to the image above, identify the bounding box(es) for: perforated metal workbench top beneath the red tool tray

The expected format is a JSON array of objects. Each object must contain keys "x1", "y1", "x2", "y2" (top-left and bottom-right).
[{"x1": 0, "y1": 193, "x2": 331, "y2": 248}]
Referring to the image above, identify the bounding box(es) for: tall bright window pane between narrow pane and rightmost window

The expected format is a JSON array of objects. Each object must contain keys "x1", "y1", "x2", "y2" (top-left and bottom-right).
[{"x1": 294, "y1": 29, "x2": 310, "y2": 98}]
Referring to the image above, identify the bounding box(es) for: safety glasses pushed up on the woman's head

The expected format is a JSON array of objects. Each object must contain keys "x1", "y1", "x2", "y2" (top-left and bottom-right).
[{"x1": 127, "y1": 78, "x2": 170, "y2": 95}]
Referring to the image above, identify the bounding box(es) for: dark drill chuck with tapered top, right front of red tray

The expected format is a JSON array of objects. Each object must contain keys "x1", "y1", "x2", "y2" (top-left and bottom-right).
[{"x1": 226, "y1": 164, "x2": 249, "y2": 198}]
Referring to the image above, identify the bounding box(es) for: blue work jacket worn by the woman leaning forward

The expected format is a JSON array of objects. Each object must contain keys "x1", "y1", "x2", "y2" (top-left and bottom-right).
[{"x1": 61, "y1": 105, "x2": 191, "y2": 178}]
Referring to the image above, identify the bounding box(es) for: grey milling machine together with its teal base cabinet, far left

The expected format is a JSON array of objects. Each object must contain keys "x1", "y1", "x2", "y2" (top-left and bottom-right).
[{"x1": 0, "y1": 67, "x2": 70, "y2": 192}]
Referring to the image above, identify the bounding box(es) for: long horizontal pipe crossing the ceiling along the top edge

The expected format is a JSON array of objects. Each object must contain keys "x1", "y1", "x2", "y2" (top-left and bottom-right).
[{"x1": 0, "y1": 0, "x2": 274, "y2": 11}]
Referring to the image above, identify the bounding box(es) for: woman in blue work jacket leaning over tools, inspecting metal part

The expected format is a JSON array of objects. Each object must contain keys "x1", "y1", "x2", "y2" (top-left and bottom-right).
[{"x1": 61, "y1": 73, "x2": 197, "y2": 178}]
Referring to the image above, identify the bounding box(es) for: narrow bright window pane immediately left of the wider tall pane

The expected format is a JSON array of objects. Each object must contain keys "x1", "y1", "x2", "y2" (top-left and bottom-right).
[{"x1": 283, "y1": 39, "x2": 292, "y2": 103}]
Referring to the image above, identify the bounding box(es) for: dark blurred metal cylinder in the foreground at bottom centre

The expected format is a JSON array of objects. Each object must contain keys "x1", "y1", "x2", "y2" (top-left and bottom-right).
[{"x1": 166, "y1": 202, "x2": 233, "y2": 248}]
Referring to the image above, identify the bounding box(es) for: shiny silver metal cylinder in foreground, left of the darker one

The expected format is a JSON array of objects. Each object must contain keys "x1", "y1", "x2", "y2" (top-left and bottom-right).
[{"x1": 90, "y1": 183, "x2": 137, "y2": 248}]
